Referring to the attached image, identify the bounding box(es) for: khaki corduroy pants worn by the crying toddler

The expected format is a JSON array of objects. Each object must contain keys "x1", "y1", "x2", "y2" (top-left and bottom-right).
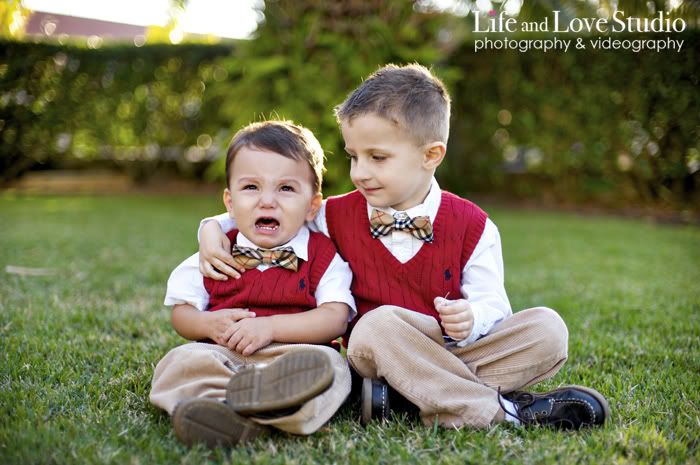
[{"x1": 149, "y1": 342, "x2": 350, "y2": 434}]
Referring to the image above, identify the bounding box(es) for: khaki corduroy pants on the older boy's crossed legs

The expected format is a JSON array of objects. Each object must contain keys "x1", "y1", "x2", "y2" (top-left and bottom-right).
[{"x1": 348, "y1": 306, "x2": 568, "y2": 427}]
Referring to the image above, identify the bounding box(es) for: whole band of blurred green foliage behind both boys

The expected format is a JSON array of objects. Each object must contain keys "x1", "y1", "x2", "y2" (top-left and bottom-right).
[{"x1": 0, "y1": 0, "x2": 700, "y2": 210}]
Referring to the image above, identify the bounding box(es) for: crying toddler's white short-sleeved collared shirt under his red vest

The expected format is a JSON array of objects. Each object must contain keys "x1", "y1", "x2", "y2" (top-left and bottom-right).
[{"x1": 164, "y1": 226, "x2": 357, "y2": 321}]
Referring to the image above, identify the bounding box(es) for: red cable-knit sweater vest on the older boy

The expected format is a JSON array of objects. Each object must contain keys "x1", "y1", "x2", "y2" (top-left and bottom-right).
[{"x1": 326, "y1": 191, "x2": 487, "y2": 321}]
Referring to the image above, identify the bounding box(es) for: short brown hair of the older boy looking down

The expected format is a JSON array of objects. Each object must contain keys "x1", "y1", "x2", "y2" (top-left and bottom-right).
[{"x1": 335, "y1": 63, "x2": 450, "y2": 144}]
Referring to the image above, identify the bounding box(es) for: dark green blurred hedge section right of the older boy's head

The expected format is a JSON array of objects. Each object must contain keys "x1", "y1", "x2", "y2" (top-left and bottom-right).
[{"x1": 445, "y1": 32, "x2": 700, "y2": 206}]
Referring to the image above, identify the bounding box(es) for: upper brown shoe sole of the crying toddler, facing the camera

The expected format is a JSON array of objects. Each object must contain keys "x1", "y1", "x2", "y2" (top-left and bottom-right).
[{"x1": 226, "y1": 351, "x2": 334, "y2": 415}]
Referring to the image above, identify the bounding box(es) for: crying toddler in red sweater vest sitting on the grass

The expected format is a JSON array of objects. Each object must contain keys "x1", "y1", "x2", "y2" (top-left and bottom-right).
[{"x1": 150, "y1": 121, "x2": 355, "y2": 446}]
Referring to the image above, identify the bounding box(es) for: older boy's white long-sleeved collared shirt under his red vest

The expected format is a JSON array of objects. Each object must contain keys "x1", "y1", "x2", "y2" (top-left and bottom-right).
[{"x1": 200, "y1": 178, "x2": 513, "y2": 347}]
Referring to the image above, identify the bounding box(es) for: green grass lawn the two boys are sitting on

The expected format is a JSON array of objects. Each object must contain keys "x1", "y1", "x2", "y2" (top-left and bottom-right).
[{"x1": 0, "y1": 195, "x2": 700, "y2": 465}]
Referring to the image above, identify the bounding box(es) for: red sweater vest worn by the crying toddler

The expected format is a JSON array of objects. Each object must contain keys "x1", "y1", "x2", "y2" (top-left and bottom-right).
[{"x1": 204, "y1": 229, "x2": 336, "y2": 316}]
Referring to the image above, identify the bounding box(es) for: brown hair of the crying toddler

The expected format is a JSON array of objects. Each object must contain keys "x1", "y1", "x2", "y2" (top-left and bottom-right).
[{"x1": 226, "y1": 120, "x2": 325, "y2": 193}]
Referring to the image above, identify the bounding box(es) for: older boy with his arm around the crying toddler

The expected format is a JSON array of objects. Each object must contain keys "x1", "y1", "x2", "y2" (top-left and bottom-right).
[{"x1": 200, "y1": 65, "x2": 609, "y2": 429}]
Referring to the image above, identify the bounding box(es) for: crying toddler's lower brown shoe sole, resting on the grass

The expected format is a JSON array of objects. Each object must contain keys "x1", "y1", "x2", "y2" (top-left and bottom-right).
[{"x1": 172, "y1": 399, "x2": 267, "y2": 448}]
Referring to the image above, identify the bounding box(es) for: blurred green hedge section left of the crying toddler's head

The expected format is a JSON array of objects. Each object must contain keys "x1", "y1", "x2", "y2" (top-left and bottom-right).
[{"x1": 0, "y1": 42, "x2": 232, "y2": 180}]
